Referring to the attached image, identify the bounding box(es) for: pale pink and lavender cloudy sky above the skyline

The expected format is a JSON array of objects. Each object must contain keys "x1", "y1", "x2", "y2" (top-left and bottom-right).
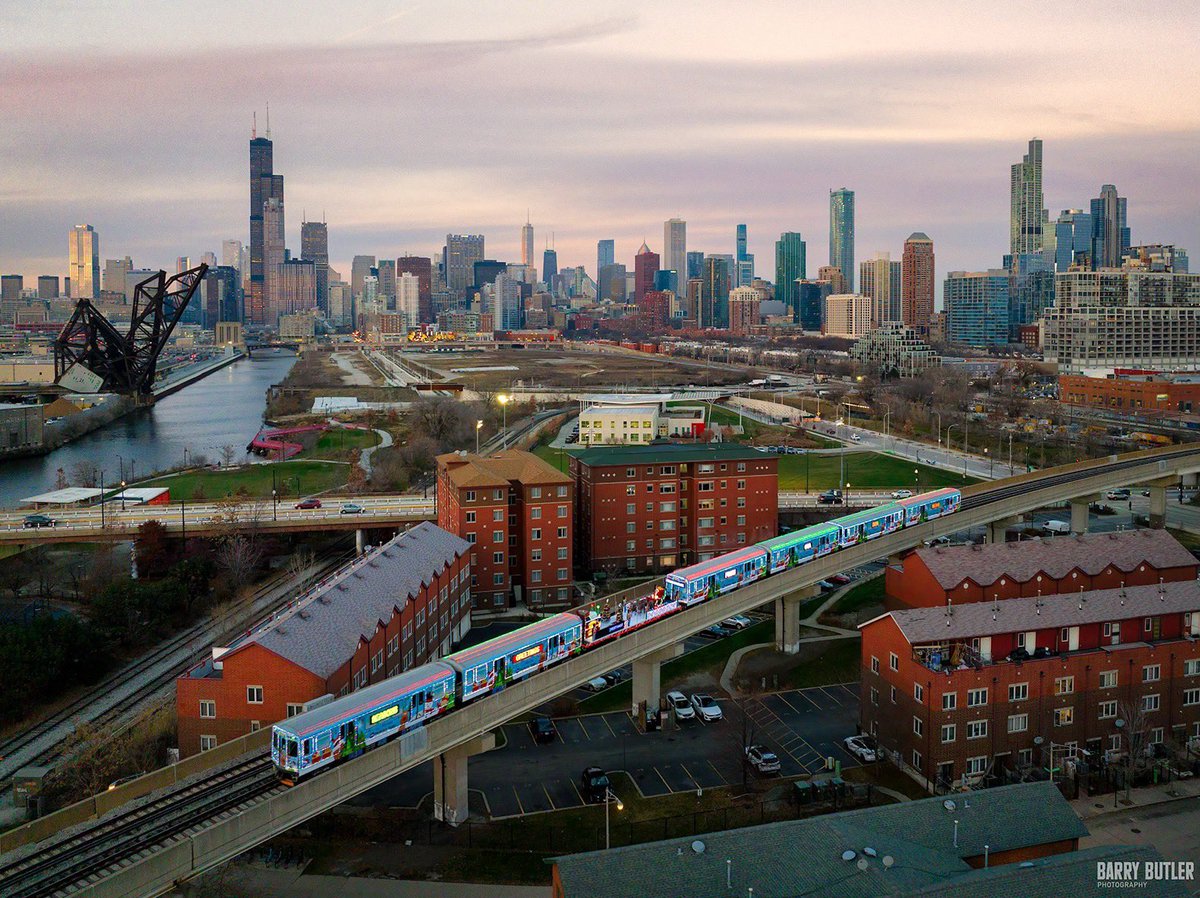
[{"x1": 0, "y1": 0, "x2": 1200, "y2": 286}]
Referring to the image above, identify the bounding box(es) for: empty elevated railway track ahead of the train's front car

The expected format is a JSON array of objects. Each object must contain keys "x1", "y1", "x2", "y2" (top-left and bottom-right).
[{"x1": 0, "y1": 758, "x2": 284, "y2": 898}]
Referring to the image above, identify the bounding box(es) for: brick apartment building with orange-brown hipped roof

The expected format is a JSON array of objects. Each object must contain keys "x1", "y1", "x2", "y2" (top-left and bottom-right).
[{"x1": 438, "y1": 449, "x2": 575, "y2": 609}]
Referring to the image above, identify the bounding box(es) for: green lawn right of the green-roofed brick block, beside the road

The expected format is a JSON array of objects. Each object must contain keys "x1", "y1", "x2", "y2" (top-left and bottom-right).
[{"x1": 779, "y1": 451, "x2": 977, "y2": 492}]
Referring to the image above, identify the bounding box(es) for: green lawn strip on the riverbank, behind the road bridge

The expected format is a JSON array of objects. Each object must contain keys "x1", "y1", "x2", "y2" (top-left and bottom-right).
[{"x1": 138, "y1": 461, "x2": 350, "y2": 502}]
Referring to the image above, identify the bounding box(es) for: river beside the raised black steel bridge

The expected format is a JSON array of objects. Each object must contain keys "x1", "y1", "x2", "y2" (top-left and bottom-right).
[{"x1": 0, "y1": 351, "x2": 296, "y2": 507}]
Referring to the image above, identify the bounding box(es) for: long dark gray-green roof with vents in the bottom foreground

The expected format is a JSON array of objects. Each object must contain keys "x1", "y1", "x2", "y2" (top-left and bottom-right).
[{"x1": 554, "y1": 783, "x2": 1087, "y2": 898}]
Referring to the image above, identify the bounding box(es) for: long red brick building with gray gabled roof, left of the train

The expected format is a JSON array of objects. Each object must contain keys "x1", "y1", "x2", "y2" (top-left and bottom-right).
[{"x1": 175, "y1": 522, "x2": 470, "y2": 758}]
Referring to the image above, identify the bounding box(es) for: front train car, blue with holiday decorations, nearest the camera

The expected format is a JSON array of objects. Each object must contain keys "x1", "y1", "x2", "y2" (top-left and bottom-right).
[{"x1": 271, "y1": 661, "x2": 457, "y2": 784}]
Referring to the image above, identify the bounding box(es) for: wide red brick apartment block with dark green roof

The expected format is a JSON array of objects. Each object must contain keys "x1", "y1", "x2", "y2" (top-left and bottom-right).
[{"x1": 570, "y1": 443, "x2": 779, "y2": 574}]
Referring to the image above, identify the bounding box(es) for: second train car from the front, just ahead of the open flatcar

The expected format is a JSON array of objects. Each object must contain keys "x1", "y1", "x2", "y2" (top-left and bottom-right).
[{"x1": 445, "y1": 612, "x2": 583, "y2": 702}]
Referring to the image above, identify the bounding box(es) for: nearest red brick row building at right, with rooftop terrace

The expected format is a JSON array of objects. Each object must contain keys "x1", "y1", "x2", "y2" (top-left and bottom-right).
[{"x1": 859, "y1": 580, "x2": 1200, "y2": 784}]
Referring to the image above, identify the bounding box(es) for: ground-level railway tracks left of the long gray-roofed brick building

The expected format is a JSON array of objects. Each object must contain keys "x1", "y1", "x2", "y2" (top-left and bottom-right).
[{"x1": 0, "y1": 542, "x2": 353, "y2": 783}]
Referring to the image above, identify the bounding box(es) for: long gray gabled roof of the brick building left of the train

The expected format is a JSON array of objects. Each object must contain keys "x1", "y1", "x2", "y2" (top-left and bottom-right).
[{"x1": 222, "y1": 521, "x2": 470, "y2": 680}]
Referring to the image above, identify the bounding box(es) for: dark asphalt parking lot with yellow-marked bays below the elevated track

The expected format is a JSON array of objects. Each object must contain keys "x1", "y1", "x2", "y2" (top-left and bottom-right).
[{"x1": 353, "y1": 683, "x2": 858, "y2": 818}]
